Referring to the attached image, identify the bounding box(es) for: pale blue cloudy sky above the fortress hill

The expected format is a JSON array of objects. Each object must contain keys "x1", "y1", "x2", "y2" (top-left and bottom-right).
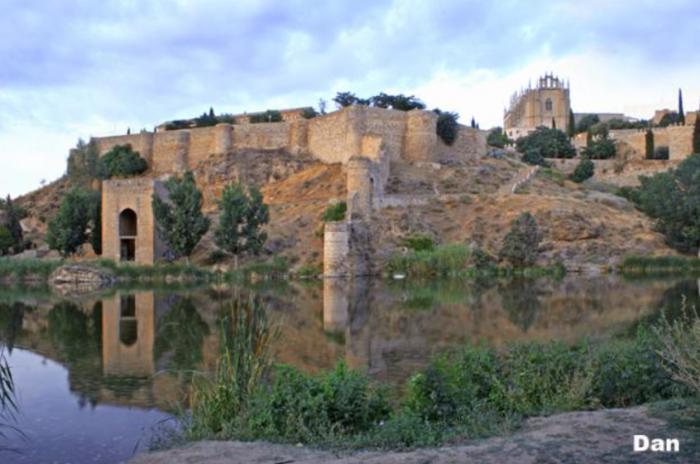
[{"x1": 0, "y1": 0, "x2": 700, "y2": 196}]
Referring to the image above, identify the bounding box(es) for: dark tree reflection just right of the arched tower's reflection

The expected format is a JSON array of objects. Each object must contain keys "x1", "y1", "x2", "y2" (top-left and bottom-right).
[{"x1": 154, "y1": 298, "x2": 209, "y2": 370}]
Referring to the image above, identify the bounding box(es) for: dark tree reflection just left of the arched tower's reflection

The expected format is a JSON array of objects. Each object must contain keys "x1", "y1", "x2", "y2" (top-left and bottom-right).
[{"x1": 49, "y1": 301, "x2": 102, "y2": 362}]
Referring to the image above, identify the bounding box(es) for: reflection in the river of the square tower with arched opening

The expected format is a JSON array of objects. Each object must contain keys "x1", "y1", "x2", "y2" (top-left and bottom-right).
[{"x1": 102, "y1": 292, "x2": 155, "y2": 377}]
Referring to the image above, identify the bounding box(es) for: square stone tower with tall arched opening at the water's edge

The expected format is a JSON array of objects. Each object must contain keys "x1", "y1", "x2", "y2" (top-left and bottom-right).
[{"x1": 102, "y1": 177, "x2": 166, "y2": 264}]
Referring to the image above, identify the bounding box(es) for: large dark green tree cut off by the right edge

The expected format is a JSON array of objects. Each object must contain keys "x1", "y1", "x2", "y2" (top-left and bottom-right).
[{"x1": 629, "y1": 154, "x2": 700, "y2": 252}]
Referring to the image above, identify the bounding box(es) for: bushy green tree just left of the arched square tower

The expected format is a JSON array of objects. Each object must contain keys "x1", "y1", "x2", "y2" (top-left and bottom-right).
[{"x1": 46, "y1": 187, "x2": 99, "y2": 256}]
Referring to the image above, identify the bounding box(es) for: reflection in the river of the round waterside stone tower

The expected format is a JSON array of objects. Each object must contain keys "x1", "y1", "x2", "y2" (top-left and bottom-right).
[{"x1": 323, "y1": 278, "x2": 370, "y2": 367}]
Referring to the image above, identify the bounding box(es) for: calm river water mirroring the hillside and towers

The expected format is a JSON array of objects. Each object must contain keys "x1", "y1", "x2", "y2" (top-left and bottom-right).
[{"x1": 0, "y1": 276, "x2": 699, "y2": 463}]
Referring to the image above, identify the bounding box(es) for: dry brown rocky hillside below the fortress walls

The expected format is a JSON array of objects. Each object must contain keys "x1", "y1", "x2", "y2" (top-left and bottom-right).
[{"x1": 12, "y1": 151, "x2": 674, "y2": 269}]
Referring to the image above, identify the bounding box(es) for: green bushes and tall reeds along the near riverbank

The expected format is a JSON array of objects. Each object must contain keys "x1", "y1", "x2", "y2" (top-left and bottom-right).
[{"x1": 183, "y1": 300, "x2": 697, "y2": 449}]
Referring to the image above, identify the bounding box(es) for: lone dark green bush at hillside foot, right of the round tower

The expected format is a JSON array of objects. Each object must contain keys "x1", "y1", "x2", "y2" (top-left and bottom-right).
[{"x1": 498, "y1": 212, "x2": 542, "y2": 267}]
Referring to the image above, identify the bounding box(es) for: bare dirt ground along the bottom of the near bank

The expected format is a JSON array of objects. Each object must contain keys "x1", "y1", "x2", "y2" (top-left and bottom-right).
[{"x1": 131, "y1": 407, "x2": 700, "y2": 464}]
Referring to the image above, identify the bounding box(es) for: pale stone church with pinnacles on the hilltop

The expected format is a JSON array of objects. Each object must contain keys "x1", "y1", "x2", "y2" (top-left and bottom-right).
[{"x1": 503, "y1": 74, "x2": 571, "y2": 139}]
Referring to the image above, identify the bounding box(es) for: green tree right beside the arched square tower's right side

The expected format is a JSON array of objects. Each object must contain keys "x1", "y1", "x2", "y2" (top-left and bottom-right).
[{"x1": 152, "y1": 171, "x2": 210, "y2": 261}]
